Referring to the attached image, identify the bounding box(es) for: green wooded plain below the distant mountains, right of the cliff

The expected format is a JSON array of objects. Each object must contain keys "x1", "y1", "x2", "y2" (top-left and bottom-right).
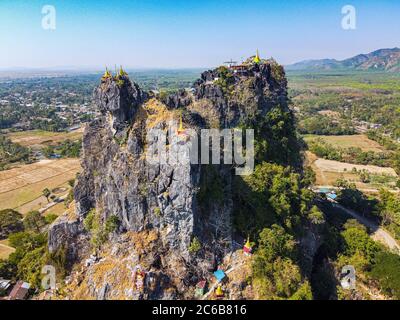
[{"x1": 287, "y1": 71, "x2": 400, "y2": 140}]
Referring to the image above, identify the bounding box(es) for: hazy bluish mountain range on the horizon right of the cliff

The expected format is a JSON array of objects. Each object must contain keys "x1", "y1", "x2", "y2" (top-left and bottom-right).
[{"x1": 285, "y1": 48, "x2": 400, "y2": 72}]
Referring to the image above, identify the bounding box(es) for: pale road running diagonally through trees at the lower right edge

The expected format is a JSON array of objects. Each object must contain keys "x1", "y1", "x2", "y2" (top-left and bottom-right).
[{"x1": 331, "y1": 201, "x2": 400, "y2": 254}]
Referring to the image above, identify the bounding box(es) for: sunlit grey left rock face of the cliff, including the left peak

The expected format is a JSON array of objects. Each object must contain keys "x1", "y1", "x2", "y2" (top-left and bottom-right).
[{"x1": 75, "y1": 84, "x2": 200, "y2": 257}]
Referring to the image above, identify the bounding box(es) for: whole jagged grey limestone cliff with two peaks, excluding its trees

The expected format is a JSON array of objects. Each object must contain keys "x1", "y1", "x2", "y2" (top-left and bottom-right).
[{"x1": 49, "y1": 61, "x2": 294, "y2": 297}]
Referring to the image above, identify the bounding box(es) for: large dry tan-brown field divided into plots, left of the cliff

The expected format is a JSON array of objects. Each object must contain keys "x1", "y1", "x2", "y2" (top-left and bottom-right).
[{"x1": 0, "y1": 159, "x2": 80, "y2": 214}]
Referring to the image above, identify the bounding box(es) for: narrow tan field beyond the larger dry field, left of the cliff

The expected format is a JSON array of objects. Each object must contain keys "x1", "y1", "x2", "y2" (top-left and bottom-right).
[{"x1": 7, "y1": 127, "x2": 84, "y2": 148}]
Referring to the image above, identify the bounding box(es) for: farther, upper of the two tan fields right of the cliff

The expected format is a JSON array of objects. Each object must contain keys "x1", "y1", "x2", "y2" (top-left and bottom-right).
[{"x1": 304, "y1": 134, "x2": 385, "y2": 152}]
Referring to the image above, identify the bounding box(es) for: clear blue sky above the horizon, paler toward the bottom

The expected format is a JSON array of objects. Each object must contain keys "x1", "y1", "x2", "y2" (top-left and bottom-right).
[{"x1": 0, "y1": 0, "x2": 400, "y2": 68}]
